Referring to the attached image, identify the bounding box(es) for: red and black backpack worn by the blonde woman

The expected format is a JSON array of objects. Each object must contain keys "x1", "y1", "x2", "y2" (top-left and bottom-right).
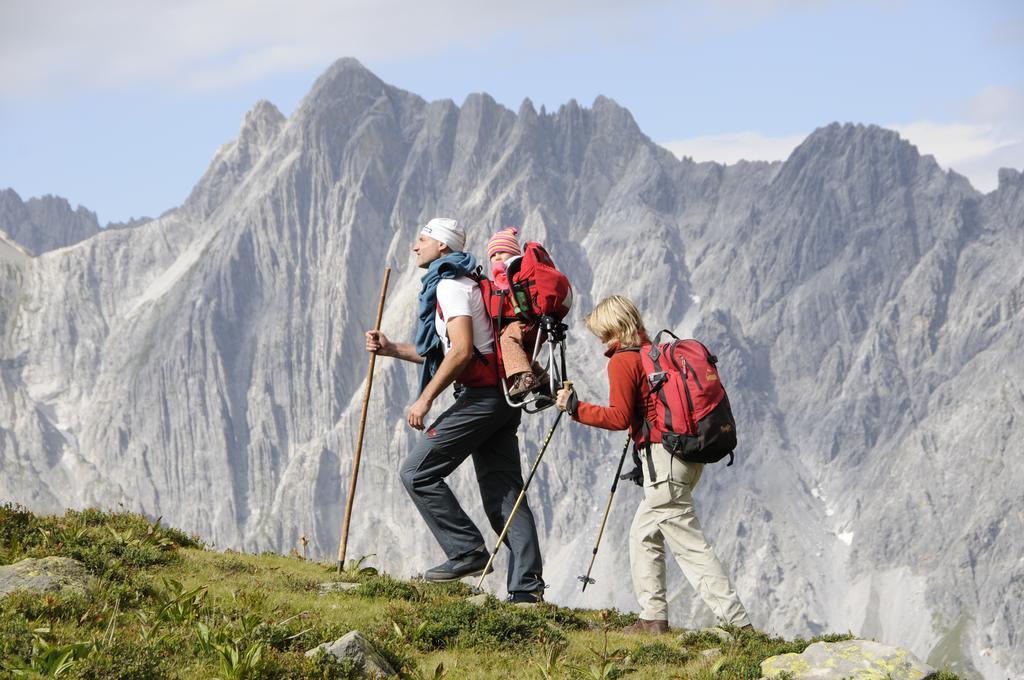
[{"x1": 637, "y1": 331, "x2": 736, "y2": 465}]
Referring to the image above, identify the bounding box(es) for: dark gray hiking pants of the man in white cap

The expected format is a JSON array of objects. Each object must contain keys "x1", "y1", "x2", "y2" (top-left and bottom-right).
[{"x1": 400, "y1": 387, "x2": 544, "y2": 593}]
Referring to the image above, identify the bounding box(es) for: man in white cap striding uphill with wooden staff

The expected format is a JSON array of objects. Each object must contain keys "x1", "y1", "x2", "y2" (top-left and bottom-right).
[{"x1": 367, "y1": 217, "x2": 544, "y2": 602}]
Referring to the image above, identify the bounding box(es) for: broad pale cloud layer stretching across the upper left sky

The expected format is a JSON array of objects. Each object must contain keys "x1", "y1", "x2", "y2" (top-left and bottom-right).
[{"x1": 0, "y1": 0, "x2": 663, "y2": 99}]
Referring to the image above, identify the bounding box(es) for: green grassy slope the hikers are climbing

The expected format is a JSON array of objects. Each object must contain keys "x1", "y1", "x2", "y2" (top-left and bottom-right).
[{"x1": 0, "y1": 506, "x2": 955, "y2": 679}]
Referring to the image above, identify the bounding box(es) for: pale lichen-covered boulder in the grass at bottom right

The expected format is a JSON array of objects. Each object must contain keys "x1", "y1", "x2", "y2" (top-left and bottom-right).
[{"x1": 761, "y1": 640, "x2": 935, "y2": 680}]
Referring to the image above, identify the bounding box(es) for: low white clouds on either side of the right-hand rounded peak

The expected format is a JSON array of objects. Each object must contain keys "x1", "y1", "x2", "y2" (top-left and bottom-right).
[{"x1": 662, "y1": 86, "x2": 1024, "y2": 193}]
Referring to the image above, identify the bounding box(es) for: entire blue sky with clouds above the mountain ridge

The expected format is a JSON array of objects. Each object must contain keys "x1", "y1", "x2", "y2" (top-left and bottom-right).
[{"x1": 0, "y1": 0, "x2": 1024, "y2": 222}]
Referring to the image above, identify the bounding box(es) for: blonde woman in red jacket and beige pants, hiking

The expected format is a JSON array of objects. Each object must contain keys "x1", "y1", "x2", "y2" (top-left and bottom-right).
[{"x1": 557, "y1": 295, "x2": 753, "y2": 633}]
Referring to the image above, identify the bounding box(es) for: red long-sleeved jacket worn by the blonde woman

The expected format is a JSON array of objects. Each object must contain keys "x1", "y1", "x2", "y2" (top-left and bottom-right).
[{"x1": 572, "y1": 345, "x2": 655, "y2": 440}]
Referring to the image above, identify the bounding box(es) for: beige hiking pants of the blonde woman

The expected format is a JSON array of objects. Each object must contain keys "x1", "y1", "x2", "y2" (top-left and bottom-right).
[{"x1": 630, "y1": 444, "x2": 751, "y2": 626}]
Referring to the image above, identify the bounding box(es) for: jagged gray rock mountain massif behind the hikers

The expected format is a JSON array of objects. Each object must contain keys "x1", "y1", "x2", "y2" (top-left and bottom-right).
[{"x1": 0, "y1": 59, "x2": 1024, "y2": 677}]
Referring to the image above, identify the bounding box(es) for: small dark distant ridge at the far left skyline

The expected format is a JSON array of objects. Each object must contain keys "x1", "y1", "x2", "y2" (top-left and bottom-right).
[{"x1": 0, "y1": 188, "x2": 99, "y2": 255}]
